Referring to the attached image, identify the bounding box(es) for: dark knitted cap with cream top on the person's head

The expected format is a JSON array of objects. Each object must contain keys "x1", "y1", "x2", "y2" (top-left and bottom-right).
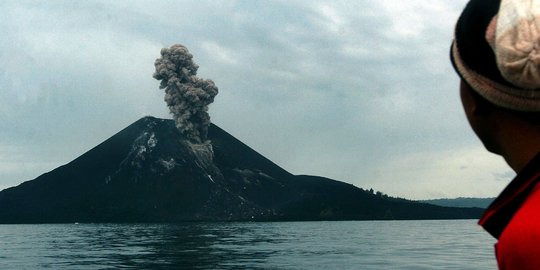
[{"x1": 450, "y1": 0, "x2": 540, "y2": 112}]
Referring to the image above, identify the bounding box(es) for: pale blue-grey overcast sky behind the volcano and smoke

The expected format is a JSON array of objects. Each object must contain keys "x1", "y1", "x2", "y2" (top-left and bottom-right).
[{"x1": 0, "y1": 0, "x2": 514, "y2": 199}]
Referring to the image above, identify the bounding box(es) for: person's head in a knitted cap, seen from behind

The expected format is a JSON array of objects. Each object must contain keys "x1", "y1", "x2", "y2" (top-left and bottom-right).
[{"x1": 450, "y1": 0, "x2": 540, "y2": 169}]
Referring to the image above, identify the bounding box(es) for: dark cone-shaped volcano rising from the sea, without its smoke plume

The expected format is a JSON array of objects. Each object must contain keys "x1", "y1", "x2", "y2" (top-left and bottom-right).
[{"x1": 0, "y1": 117, "x2": 482, "y2": 223}]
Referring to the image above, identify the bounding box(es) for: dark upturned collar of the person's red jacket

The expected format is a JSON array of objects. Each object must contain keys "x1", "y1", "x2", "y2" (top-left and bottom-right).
[{"x1": 478, "y1": 154, "x2": 540, "y2": 239}]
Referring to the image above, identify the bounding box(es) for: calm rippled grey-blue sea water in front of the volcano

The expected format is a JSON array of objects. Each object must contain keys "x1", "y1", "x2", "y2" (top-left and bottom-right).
[{"x1": 0, "y1": 220, "x2": 496, "y2": 270}]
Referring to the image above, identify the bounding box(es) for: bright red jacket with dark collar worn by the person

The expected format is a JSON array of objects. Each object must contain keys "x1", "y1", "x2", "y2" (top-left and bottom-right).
[{"x1": 479, "y1": 155, "x2": 540, "y2": 270}]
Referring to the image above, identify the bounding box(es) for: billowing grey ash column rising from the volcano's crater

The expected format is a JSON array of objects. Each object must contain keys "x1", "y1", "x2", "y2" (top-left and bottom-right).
[{"x1": 154, "y1": 44, "x2": 218, "y2": 144}]
